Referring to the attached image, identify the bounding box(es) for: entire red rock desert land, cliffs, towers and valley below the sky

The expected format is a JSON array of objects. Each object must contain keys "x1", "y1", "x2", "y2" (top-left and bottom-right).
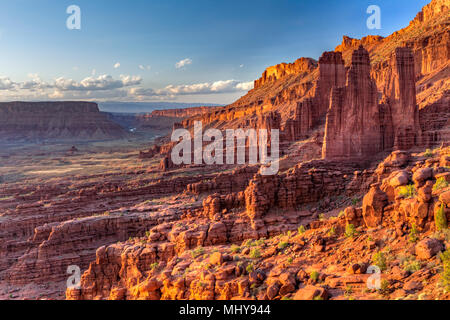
[{"x1": 0, "y1": 0, "x2": 450, "y2": 300}]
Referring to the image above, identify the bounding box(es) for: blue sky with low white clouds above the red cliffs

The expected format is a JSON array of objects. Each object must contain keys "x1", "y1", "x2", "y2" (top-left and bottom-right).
[{"x1": 0, "y1": 0, "x2": 429, "y2": 103}]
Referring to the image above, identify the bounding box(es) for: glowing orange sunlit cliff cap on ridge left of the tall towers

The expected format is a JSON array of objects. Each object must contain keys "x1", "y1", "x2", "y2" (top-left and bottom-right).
[{"x1": 255, "y1": 58, "x2": 317, "y2": 89}]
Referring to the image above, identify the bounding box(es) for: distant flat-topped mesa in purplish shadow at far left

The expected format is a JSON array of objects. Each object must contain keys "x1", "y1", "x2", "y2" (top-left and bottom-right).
[{"x1": 0, "y1": 102, "x2": 126, "y2": 141}]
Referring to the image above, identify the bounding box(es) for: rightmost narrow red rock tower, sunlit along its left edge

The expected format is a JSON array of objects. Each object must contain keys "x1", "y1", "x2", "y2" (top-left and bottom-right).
[{"x1": 383, "y1": 47, "x2": 421, "y2": 150}]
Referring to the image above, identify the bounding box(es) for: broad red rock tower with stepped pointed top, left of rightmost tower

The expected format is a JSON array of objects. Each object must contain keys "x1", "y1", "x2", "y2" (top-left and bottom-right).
[{"x1": 322, "y1": 46, "x2": 381, "y2": 159}]
